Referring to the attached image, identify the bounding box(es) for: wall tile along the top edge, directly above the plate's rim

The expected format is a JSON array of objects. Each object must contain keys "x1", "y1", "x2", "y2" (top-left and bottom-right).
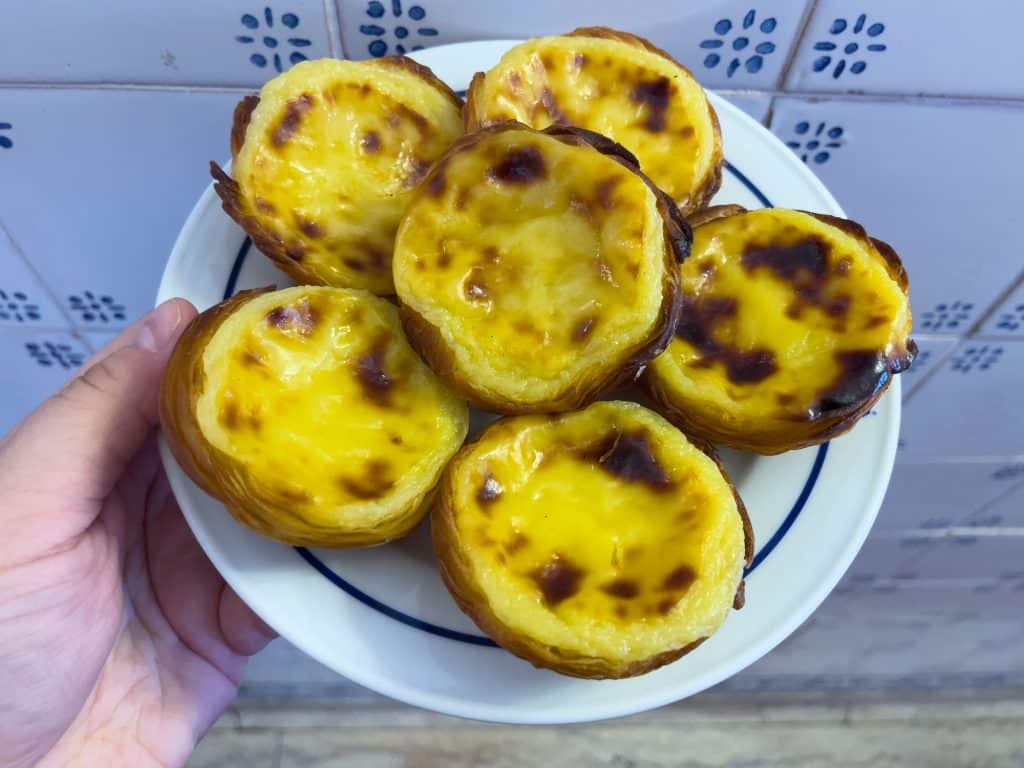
[{"x1": 339, "y1": 0, "x2": 806, "y2": 88}]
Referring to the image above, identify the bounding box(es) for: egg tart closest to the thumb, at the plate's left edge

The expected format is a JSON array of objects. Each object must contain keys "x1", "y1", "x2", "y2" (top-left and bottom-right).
[{"x1": 161, "y1": 287, "x2": 469, "y2": 547}]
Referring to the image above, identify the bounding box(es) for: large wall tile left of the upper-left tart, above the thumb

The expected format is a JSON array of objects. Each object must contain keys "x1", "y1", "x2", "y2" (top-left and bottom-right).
[{"x1": 0, "y1": 89, "x2": 239, "y2": 330}]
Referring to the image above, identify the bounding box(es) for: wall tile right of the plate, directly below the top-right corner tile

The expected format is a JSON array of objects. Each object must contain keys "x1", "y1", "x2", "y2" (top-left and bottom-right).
[{"x1": 772, "y1": 98, "x2": 1024, "y2": 335}]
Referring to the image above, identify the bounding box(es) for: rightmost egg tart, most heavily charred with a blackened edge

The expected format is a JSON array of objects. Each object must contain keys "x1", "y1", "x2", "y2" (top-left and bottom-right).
[{"x1": 644, "y1": 207, "x2": 916, "y2": 454}]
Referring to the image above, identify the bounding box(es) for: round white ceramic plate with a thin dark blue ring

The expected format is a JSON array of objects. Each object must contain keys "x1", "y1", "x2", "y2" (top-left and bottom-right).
[{"x1": 159, "y1": 41, "x2": 900, "y2": 723}]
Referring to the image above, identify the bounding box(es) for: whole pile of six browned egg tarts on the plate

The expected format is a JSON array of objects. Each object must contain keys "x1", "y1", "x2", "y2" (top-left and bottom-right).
[{"x1": 161, "y1": 28, "x2": 915, "y2": 678}]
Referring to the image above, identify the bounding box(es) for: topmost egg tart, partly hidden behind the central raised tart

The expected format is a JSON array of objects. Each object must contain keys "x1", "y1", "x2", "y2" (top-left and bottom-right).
[{"x1": 465, "y1": 27, "x2": 723, "y2": 213}]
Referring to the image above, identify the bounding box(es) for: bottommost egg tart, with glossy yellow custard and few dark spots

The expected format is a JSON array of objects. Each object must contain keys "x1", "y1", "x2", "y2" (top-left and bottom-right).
[{"x1": 431, "y1": 401, "x2": 754, "y2": 678}]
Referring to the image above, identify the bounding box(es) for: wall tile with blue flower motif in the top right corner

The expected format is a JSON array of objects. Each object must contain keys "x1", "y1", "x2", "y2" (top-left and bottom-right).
[{"x1": 786, "y1": 0, "x2": 1024, "y2": 96}]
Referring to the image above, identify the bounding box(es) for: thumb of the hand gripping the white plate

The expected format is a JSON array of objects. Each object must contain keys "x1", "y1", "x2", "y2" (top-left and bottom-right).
[{"x1": 0, "y1": 299, "x2": 196, "y2": 512}]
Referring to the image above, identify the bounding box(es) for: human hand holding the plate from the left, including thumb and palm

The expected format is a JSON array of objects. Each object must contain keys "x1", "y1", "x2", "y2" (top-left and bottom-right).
[{"x1": 0, "y1": 299, "x2": 273, "y2": 768}]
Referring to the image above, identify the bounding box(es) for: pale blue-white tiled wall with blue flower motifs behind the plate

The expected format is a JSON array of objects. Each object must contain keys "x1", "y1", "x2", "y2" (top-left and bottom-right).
[{"x1": 0, "y1": 0, "x2": 1024, "y2": 684}]
